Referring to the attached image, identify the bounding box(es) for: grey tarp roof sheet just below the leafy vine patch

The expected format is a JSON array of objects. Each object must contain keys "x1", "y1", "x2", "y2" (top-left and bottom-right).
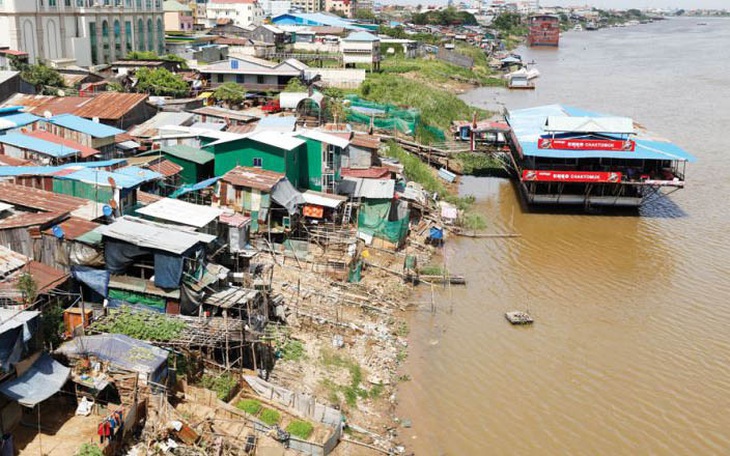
[{"x1": 56, "y1": 334, "x2": 168, "y2": 383}]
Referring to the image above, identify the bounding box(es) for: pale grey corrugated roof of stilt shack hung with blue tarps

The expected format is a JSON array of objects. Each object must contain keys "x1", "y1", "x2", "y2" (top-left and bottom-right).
[{"x1": 94, "y1": 216, "x2": 215, "y2": 255}]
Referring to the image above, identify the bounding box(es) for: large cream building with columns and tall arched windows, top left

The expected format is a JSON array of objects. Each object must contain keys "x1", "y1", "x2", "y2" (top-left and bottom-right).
[{"x1": 0, "y1": 0, "x2": 165, "y2": 66}]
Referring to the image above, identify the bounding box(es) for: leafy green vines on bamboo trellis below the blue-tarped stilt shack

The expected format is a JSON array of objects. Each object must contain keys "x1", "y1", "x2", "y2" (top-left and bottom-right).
[{"x1": 90, "y1": 307, "x2": 187, "y2": 341}]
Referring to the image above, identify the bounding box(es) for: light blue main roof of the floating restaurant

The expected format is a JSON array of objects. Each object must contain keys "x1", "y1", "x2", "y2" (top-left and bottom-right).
[{"x1": 507, "y1": 105, "x2": 696, "y2": 162}]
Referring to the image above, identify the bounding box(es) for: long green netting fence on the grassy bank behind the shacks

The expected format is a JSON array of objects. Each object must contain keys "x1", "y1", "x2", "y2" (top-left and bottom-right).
[{"x1": 346, "y1": 95, "x2": 446, "y2": 140}]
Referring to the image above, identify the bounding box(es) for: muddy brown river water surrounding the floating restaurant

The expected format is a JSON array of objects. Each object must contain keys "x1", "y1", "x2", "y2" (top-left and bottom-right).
[{"x1": 398, "y1": 18, "x2": 730, "y2": 455}]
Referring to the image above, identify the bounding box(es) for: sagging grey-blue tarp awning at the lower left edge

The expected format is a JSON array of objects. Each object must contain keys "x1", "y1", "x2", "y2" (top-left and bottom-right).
[{"x1": 0, "y1": 353, "x2": 71, "y2": 407}]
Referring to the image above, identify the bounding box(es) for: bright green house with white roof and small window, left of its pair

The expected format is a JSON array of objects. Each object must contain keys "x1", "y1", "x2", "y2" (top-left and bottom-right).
[{"x1": 205, "y1": 131, "x2": 306, "y2": 187}]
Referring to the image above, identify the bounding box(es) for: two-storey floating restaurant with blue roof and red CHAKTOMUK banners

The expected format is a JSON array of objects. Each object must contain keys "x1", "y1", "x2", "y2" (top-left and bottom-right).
[{"x1": 507, "y1": 105, "x2": 695, "y2": 208}]
